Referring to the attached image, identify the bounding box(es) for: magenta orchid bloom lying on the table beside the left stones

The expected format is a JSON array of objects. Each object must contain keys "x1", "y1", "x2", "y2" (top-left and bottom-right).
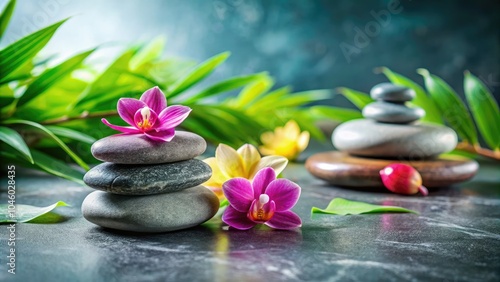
[{"x1": 222, "y1": 167, "x2": 302, "y2": 230}]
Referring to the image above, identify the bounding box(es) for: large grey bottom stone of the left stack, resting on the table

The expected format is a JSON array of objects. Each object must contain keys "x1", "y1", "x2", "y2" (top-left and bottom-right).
[{"x1": 82, "y1": 186, "x2": 219, "y2": 232}]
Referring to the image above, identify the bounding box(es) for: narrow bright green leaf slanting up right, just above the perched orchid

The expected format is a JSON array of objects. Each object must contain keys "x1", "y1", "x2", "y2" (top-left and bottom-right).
[{"x1": 167, "y1": 52, "x2": 230, "y2": 98}]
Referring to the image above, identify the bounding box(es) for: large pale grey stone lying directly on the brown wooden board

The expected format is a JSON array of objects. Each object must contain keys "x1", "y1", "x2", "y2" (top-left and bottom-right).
[{"x1": 332, "y1": 119, "x2": 457, "y2": 159}]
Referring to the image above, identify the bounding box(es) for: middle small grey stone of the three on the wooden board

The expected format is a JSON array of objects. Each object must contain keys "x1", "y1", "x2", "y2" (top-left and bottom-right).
[{"x1": 363, "y1": 101, "x2": 425, "y2": 123}]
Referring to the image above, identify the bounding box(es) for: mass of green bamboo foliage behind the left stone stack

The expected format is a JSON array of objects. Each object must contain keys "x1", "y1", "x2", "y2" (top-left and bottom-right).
[{"x1": 0, "y1": 0, "x2": 336, "y2": 182}]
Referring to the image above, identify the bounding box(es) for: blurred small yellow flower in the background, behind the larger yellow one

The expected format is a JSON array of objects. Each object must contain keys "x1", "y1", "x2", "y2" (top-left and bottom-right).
[{"x1": 259, "y1": 120, "x2": 310, "y2": 160}]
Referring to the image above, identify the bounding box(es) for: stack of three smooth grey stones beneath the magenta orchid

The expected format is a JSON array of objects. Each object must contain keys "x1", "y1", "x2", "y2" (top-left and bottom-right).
[{"x1": 82, "y1": 131, "x2": 219, "y2": 232}]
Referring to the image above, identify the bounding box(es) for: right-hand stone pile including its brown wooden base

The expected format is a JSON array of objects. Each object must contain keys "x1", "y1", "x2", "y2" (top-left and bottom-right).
[{"x1": 306, "y1": 83, "x2": 478, "y2": 188}]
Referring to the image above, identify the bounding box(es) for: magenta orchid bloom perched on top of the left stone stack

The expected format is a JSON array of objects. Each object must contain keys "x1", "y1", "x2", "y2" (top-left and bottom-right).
[{"x1": 102, "y1": 86, "x2": 191, "y2": 142}]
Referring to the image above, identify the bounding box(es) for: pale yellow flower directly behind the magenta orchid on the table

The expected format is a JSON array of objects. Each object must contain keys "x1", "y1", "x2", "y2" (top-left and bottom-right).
[{"x1": 202, "y1": 144, "x2": 288, "y2": 199}]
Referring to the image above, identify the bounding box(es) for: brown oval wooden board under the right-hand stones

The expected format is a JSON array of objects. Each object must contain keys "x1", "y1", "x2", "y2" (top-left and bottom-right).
[{"x1": 306, "y1": 151, "x2": 479, "y2": 187}]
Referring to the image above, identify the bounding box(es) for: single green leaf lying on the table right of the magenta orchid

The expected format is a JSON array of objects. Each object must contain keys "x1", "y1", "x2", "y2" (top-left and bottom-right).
[{"x1": 311, "y1": 198, "x2": 417, "y2": 215}]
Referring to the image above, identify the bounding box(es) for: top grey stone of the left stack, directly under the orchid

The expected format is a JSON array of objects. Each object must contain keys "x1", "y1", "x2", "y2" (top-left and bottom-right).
[{"x1": 90, "y1": 131, "x2": 207, "y2": 164}]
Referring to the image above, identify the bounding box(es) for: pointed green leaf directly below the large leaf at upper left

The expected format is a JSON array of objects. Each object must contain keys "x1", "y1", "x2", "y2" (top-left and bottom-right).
[{"x1": 17, "y1": 49, "x2": 95, "y2": 107}]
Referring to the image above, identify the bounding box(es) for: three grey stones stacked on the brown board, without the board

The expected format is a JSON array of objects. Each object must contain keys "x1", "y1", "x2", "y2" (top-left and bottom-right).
[{"x1": 332, "y1": 83, "x2": 457, "y2": 160}]
